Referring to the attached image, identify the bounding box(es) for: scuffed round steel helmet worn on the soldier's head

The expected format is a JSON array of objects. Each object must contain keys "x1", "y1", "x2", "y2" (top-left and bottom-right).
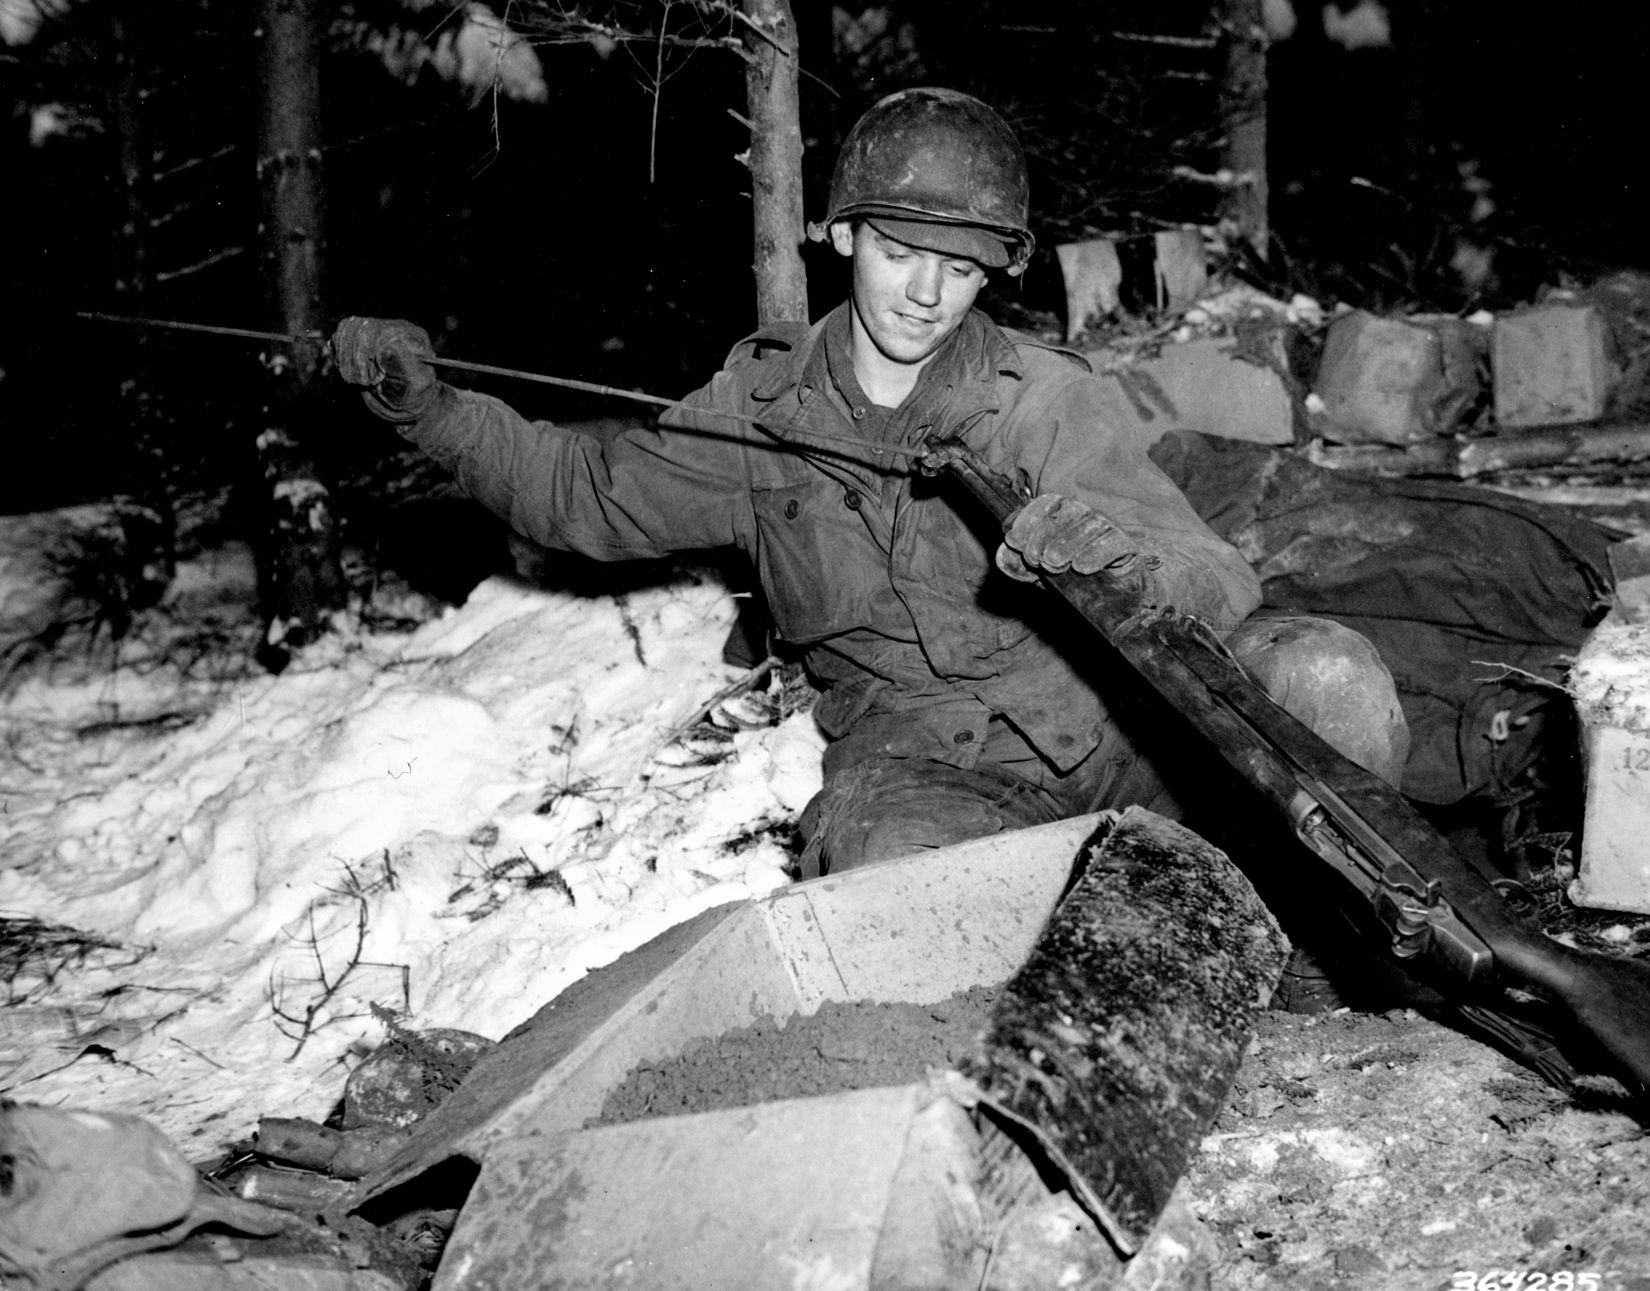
[{"x1": 809, "y1": 87, "x2": 1035, "y2": 274}]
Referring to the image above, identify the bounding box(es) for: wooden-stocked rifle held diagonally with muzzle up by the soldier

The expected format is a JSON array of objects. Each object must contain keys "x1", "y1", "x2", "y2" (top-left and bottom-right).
[{"x1": 921, "y1": 439, "x2": 1650, "y2": 1098}]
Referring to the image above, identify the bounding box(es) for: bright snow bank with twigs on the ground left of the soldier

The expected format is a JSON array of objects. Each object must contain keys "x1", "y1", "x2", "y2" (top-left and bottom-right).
[{"x1": 0, "y1": 508, "x2": 823, "y2": 1156}]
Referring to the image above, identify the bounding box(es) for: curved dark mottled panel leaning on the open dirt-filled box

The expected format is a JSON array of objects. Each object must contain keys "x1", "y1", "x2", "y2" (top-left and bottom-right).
[{"x1": 962, "y1": 811, "x2": 1287, "y2": 1253}]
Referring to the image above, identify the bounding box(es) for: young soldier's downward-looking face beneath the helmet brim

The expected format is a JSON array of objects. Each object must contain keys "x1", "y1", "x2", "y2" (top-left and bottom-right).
[{"x1": 830, "y1": 221, "x2": 985, "y2": 366}]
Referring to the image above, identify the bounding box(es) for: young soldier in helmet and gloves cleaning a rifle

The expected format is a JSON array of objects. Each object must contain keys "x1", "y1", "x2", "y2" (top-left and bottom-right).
[{"x1": 333, "y1": 89, "x2": 1407, "y2": 877}]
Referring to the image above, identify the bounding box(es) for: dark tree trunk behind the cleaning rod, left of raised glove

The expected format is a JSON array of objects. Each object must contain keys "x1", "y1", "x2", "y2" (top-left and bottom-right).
[{"x1": 257, "y1": 0, "x2": 347, "y2": 670}]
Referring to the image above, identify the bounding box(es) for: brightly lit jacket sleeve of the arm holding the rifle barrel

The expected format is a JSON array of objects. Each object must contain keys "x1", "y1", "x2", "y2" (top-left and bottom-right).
[{"x1": 992, "y1": 358, "x2": 1261, "y2": 631}]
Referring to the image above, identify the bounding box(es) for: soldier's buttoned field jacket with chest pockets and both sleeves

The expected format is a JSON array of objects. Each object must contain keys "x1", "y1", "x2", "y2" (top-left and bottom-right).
[{"x1": 401, "y1": 305, "x2": 1261, "y2": 773}]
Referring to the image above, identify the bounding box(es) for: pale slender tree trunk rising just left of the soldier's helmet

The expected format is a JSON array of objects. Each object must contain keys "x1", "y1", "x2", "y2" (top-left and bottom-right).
[{"x1": 743, "y1": 0, "x2": 809, "y2": 324}]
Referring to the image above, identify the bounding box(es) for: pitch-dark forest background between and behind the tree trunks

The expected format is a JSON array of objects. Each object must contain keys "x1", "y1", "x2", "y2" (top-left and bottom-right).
[{"x1": 0, "y1": 0, "x2": 1650, "y2": 510}]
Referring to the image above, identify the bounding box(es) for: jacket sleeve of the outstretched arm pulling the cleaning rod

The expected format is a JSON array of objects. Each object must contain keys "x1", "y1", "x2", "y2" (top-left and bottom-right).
[{"x1": 398, "y1": 373, "x2": 751, "y2": 560}]
